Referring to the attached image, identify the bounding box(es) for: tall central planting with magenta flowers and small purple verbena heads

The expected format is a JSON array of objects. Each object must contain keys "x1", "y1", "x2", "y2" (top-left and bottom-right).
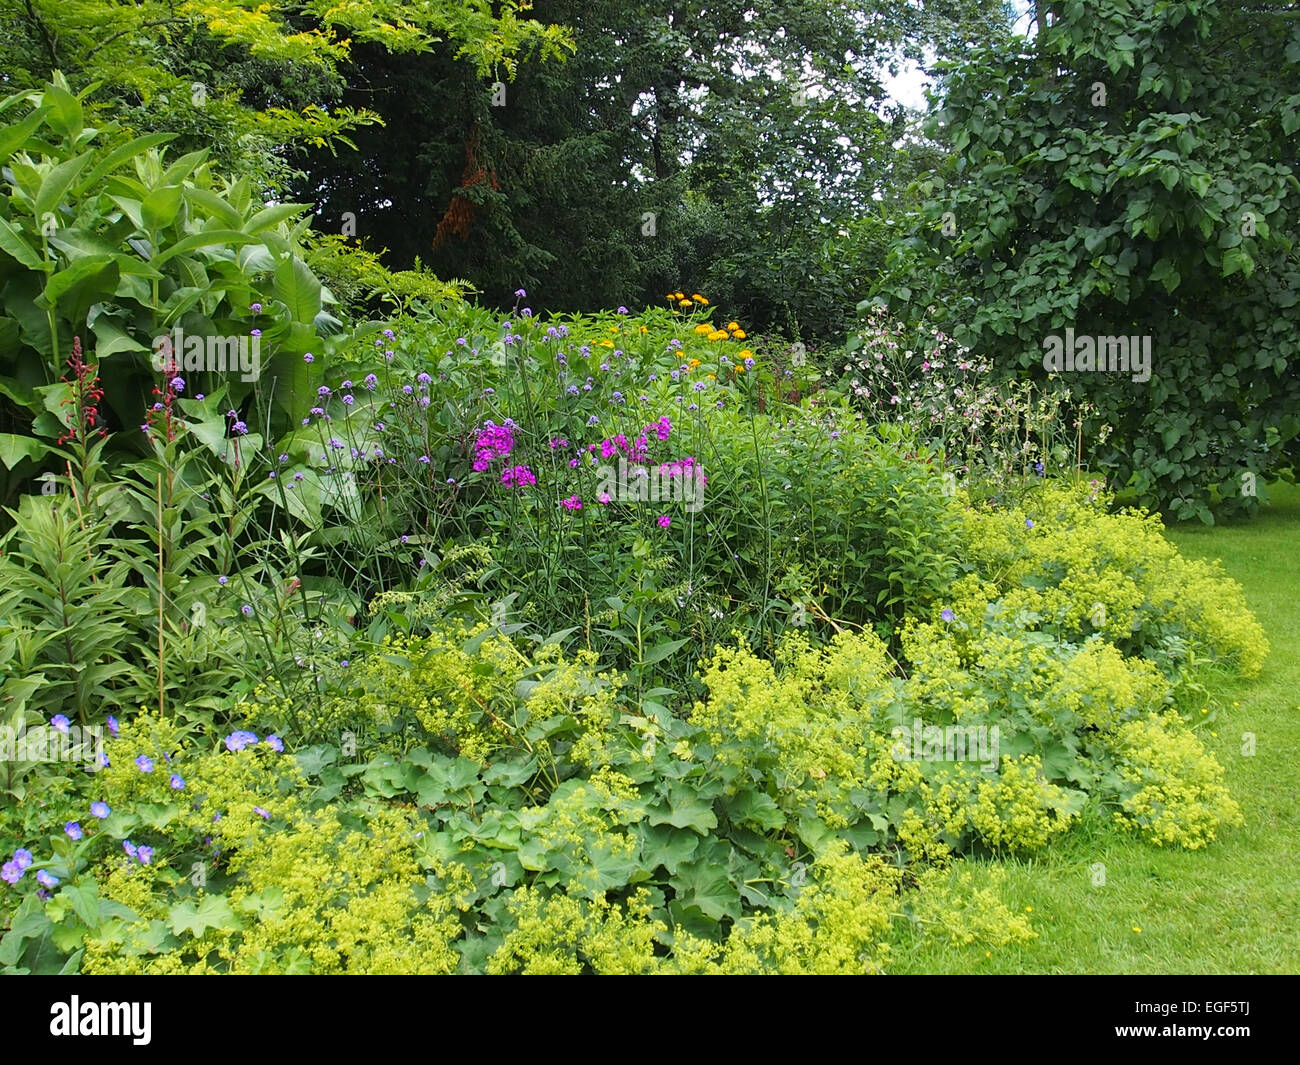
[{"x1": 220, "y1": 296, "x2": 957, "y2": 684}]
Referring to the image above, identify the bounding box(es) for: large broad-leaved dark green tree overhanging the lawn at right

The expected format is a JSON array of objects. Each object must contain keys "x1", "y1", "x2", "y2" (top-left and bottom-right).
[{"x1": 880, "y1": 0, "x2": 1300, "y2": 521}]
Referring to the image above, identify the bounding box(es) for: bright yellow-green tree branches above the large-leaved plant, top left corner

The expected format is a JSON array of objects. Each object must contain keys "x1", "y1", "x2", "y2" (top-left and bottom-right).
[{"x1": 0, "y1": 0, "x2": 573, "y2": 191}]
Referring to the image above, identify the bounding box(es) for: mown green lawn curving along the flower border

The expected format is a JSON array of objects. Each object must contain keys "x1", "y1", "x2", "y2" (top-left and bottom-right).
[{"x1": 892, "y1": 485, "x2": 1300, "y2": 974}]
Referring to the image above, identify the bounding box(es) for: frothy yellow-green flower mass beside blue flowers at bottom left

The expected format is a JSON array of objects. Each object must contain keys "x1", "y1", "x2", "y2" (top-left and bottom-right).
[{"x1": 83, "y1": 745, "x2": 468, "y2": 973}]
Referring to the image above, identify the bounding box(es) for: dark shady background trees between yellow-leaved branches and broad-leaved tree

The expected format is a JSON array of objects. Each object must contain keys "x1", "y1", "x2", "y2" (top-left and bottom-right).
[{"x1": 299, "y1": 0, "x2": 1005, "y2": 335}]
